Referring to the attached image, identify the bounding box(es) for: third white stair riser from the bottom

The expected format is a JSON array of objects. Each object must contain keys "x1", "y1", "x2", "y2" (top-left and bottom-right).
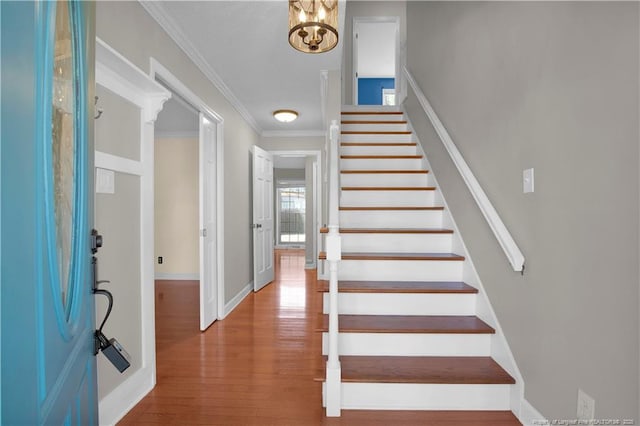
[{"x1": 322, "y1": 293, "x2": 476, "y2": 315}]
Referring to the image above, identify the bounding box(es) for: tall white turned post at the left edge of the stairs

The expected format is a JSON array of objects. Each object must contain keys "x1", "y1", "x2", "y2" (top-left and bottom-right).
[{"x1": 325, "y1": 120, "x2": 342, "y2": 417}]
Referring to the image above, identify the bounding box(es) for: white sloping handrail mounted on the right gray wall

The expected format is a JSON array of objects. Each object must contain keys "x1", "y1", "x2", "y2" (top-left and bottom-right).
[{"x1": 404, "y1": 68, "x2": 525, "y2": 272}]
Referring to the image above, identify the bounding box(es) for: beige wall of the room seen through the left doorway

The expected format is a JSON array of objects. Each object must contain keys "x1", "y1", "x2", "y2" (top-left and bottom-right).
[{"x1": 154, "y1": 138, "x2": 200, "y2": 279}]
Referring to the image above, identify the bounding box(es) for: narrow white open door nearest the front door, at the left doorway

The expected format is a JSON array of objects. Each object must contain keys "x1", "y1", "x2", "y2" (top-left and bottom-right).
[{"x1": 200, "y1": 113, "x2": 218, "y2": 331}]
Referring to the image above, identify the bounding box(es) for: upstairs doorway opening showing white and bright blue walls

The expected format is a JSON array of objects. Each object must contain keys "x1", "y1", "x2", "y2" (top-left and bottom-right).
[{"x1": 353, "y1": 17, "x2": 400, "y2": 105}]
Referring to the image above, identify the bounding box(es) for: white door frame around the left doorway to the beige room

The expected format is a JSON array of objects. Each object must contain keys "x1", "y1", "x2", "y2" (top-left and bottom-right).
[{"x1": 151, "y1": 58, "x2": 225, "y2": 324}]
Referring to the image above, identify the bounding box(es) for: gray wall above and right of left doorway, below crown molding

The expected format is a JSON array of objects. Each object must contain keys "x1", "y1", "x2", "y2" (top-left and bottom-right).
[{"x1": 97, "y1": 2, "x2": 258, "y2": 302}]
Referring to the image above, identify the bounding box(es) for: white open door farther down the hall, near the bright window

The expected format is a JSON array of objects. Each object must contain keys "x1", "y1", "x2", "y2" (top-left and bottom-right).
[{"x1": 252, "y1": 145, "x2": 275, "y2": 291}]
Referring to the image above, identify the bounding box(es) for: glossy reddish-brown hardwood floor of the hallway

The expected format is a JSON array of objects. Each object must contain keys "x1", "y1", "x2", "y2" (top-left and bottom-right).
[{"x1": 119, "y1": 250, "x2": 520, "y2": 426}]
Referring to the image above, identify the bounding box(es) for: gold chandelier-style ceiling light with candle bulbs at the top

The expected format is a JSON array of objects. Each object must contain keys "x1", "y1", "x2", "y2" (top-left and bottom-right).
[{"x1": 289, "y1": 0, "x2": 338, "y2": 53}]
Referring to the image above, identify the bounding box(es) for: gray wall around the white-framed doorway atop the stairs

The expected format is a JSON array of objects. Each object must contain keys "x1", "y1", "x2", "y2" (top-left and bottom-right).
[{"x1": 342, "y1": 0, "x2": 407, "y2": 105}]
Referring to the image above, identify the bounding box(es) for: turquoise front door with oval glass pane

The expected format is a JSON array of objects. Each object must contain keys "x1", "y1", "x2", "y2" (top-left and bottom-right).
[{"x1": 0, "y1": 1, "x2": 98, "y2": 425}]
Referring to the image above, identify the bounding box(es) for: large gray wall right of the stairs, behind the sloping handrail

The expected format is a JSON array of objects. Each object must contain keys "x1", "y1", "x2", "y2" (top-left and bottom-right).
[{"x1": 406, "y1": 2, "x2": 640, "y2": 422}]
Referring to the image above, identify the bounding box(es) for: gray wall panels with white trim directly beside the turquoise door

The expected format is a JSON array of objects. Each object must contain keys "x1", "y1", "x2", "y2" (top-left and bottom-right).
[{"x1": 95, "y1": 85, "x2": 142, "y2": 399}]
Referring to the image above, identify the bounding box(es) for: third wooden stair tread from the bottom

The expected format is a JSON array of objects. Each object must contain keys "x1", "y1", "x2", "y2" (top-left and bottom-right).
[{"x1": 318, "y1": 280, "x2": 478, "y2": 294}]
